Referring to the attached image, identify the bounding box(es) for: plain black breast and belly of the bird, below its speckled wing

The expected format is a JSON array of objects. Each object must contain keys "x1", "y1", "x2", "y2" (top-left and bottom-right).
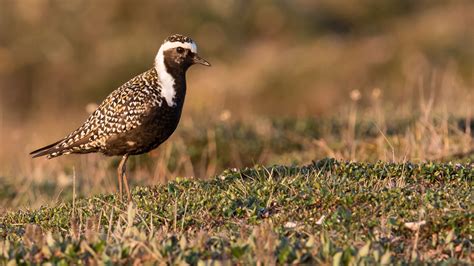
[{"x1": 101, "y1": 102, "x2": 182, "y2": 156}]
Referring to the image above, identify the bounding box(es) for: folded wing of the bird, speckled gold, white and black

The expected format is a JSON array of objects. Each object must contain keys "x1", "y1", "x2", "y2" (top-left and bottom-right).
[{"x1": 33, "y1": 68, "x2": 162, "y2": 158}]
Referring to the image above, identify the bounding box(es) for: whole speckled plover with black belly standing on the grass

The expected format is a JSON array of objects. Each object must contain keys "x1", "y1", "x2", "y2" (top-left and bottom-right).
[{"x1": 30, "y1": 34, "x2": 211, "y2": 201}]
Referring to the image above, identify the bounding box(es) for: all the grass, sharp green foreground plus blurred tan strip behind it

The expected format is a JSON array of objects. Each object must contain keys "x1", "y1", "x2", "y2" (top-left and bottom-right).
[{"x1": 0, "y1": 108, "x2": 474, "y2": 265}]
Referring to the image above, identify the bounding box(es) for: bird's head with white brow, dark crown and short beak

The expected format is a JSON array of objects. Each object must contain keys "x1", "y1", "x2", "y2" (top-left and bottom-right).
[{"x1": 155, "y1": 34, "x2": 211, "y2": 71}]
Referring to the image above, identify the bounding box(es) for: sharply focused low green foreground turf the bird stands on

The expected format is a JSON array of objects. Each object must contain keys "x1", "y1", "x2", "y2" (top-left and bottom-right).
[{"x1": 0, "y1": 159, "x2": 474, "y2": 264}]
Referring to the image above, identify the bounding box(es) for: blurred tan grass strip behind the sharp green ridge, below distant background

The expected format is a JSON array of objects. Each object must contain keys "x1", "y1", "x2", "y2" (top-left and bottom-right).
[{"x1": 0, "y1": 112, "x2": 474, "y2": 210}]
